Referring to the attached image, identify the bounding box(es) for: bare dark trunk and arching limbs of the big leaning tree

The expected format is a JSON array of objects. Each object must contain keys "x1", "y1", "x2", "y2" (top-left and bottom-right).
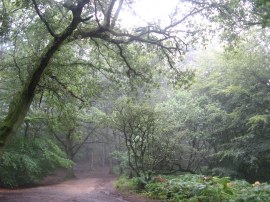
[{"x1": 0, "y1": 0, "x2": 207, "y2": 157}]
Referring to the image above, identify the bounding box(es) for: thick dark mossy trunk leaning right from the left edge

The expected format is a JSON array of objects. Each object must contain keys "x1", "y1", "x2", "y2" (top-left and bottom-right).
[{"x1": 0, "y1": 0, "x2": 88, "y2": 157}]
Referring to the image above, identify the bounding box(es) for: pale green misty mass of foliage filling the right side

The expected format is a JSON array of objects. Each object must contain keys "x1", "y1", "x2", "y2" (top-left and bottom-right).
[{"x1": 160, "y1": 36, "x2": 270, "y2": 182}]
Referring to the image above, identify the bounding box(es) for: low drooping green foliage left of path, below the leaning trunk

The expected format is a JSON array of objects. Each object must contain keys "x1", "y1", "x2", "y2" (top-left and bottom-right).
[{"x1": 0, "y1": 137, "x2": 72, "y2": 188}]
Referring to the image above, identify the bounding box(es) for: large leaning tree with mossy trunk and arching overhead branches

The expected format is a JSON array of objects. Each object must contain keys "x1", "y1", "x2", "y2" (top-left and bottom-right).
[{"x1": 0, "y1": 0, "x2": 206, "y2": 155}]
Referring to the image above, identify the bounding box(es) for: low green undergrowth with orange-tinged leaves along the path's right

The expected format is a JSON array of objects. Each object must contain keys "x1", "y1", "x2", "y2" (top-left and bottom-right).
[{"x1": 115, "y1": 174, "x2": 270, "y2": 202}]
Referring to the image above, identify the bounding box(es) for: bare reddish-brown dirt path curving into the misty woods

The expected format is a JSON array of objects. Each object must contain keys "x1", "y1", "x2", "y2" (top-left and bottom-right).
[{"x1": 0, "y1": 164, "x2": 157, "y2": 202}]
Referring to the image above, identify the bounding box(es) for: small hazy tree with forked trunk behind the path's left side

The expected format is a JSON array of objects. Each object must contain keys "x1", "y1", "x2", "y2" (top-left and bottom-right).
[{"x1": 46, "y1": 102, "x2": 104, "y2": 178}]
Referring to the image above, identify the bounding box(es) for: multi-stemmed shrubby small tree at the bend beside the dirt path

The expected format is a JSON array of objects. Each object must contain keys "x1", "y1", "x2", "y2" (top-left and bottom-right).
[{"x1": 110, "y1": 98, "x2": 186, "y2": 181}]
